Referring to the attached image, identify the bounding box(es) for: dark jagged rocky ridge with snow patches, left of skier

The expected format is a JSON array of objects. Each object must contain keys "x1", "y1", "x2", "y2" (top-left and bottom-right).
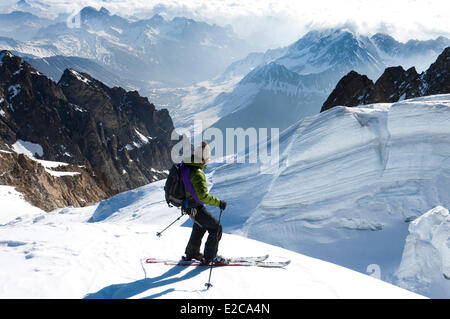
[{"x1": 0, "y1": 51, "x2": 174, "y2": 212}]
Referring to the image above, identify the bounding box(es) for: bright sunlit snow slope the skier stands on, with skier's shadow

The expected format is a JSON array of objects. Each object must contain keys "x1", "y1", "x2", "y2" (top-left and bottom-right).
[{"x1": 0, "y1": 181, "x2": 421, "y2": 300}]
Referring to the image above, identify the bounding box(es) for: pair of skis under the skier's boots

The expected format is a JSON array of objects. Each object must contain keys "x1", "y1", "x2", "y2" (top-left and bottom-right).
[{"x1": 145, "y1": 255, "x2": 291, "y2": 268}]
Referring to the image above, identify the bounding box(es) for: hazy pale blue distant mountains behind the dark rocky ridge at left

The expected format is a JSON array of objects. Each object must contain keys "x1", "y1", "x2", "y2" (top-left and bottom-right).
[{"x1": 3, "y1": 7, "x2": 253, "y2": 85}]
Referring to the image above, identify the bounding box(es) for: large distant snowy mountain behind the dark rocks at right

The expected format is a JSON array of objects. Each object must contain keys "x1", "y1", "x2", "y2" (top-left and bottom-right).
[{"x1": 169, "y1": 29, "x2": 450, "y2": 135}]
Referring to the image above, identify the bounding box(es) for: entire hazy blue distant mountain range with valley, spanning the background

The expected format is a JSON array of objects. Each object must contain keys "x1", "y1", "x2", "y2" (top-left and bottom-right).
[{"x1": 0, "y1": 7, "x2": 450, "y2": 136}]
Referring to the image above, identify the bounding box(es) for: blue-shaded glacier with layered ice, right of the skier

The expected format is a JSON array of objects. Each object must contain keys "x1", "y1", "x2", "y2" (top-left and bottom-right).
[{"x1": 203, "y1": 94, "x2": 450, "y2": 297}]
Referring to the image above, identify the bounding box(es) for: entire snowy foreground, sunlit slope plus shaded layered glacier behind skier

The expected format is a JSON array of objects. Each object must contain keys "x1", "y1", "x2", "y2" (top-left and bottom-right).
[{"x1": 0, "y1": 94, "x2": 450, "y2": 298}]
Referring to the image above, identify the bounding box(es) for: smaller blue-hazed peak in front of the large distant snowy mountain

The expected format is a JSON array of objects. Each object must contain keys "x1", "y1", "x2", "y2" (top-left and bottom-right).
[{"x1": 207, "y1": 62, "x2": 324, "y2": 132}]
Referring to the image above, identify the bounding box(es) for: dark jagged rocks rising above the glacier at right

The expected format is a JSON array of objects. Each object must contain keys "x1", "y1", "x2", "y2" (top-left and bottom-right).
[{"x1": 321, "y1": 47, "x2": 450, "y2": 112}]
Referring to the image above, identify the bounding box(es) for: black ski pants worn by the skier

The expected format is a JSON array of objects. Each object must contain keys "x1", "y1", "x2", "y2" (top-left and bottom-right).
[{"x1": 185, "y1": 206, "x2": 222, "y2": 260}]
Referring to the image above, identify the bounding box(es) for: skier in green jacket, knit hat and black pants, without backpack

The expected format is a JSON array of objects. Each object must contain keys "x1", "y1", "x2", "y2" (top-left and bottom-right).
[{"x1": 183, "y1": 141, "x2": 227, "y2": 265}]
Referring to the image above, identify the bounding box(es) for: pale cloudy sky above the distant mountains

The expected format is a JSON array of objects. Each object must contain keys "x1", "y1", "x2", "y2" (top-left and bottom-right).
[{"x1": 0, "y1": 0, "x2": 450, "y2": 47}]
